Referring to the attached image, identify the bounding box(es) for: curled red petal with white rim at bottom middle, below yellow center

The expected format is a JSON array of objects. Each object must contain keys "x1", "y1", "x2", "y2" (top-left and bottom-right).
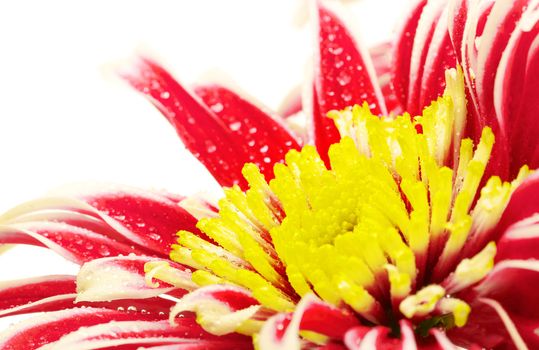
[{"x1": 259, "y1": 294, "x2": 359, "y2": 349}]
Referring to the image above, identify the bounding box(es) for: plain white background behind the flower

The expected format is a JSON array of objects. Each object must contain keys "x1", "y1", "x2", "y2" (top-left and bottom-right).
[{"x1": 0, "y1": 0, "x2": 407, "y2": 330}]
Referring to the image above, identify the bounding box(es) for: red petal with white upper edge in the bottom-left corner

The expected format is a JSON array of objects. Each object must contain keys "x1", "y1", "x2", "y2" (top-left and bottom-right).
[{"x1": 0, "y1": 307, "x2": 158, "y2": 350}]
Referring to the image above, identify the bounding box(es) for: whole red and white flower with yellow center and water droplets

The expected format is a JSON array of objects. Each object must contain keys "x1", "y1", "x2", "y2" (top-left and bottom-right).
[{"x1": 0, "y1": 0, "x2": 539, "y2": 349}]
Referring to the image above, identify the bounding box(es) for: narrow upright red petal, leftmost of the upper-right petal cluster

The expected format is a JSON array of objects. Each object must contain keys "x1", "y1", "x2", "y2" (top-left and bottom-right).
[{"x1": 392, "y1": 0, "x2": 427, "y2": 109}]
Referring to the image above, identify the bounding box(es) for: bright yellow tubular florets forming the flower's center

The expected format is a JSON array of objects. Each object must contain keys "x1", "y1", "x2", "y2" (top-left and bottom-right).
[{"x1": 147, "y1": 68, "x2": 528, "y2": 336}]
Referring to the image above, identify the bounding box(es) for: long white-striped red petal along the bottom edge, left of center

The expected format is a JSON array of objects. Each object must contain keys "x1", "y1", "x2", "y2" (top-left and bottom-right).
[{"x1": 41, "y1": 317, "x2": 249, "y2": 350}]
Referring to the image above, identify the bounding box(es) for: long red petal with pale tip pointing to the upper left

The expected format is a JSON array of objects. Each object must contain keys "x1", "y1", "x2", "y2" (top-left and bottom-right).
[{"x1": 120, "y1": 58, "x2": 248, "y2": 186}]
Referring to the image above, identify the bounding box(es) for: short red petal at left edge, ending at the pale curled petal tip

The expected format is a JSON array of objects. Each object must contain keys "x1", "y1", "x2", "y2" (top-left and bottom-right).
[{"x1": 0, "y1": 275, "x2": 76, "y2": 317}]
